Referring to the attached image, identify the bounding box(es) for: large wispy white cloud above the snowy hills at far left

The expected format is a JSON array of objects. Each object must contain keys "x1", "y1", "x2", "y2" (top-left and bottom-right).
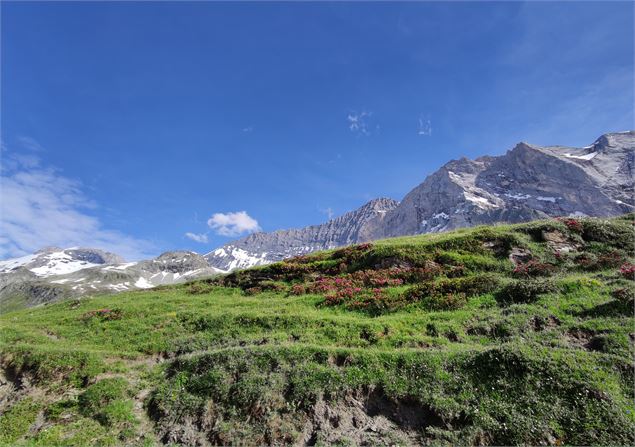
[{"x1": 0, "y1": 145, "x2": 155, "y2": 260}]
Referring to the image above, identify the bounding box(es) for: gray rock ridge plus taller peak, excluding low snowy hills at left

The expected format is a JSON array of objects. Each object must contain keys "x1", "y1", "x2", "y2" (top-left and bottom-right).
[{"x1": 205, "y1": 131, "x2": 635, "y2": 271}]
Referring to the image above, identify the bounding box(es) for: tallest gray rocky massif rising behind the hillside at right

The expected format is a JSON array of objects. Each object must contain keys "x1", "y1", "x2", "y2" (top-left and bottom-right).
[{"x1": 370, "y1": 131, "x2": 635, "y2": 239}]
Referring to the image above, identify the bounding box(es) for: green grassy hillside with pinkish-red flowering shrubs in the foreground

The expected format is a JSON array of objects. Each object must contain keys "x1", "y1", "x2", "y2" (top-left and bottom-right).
[{"x1": 0, "y1": 215, "x2": 635, "y2": 445}]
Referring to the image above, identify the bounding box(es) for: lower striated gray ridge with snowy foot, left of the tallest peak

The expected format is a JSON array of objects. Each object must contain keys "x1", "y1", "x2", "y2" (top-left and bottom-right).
[{"x1": 205, "y1": 198, "x2": 398, "y2": 271}]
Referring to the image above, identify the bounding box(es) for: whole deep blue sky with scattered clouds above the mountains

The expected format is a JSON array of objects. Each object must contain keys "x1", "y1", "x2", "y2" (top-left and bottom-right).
[{"x1": 0, "y1": 2, "x2": 635, "y2": 258}]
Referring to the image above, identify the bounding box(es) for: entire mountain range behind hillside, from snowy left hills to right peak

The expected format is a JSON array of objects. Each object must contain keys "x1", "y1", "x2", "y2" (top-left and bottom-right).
[{"x1": 0, "y1": 131, "x2": 635, "y2": 311}]
